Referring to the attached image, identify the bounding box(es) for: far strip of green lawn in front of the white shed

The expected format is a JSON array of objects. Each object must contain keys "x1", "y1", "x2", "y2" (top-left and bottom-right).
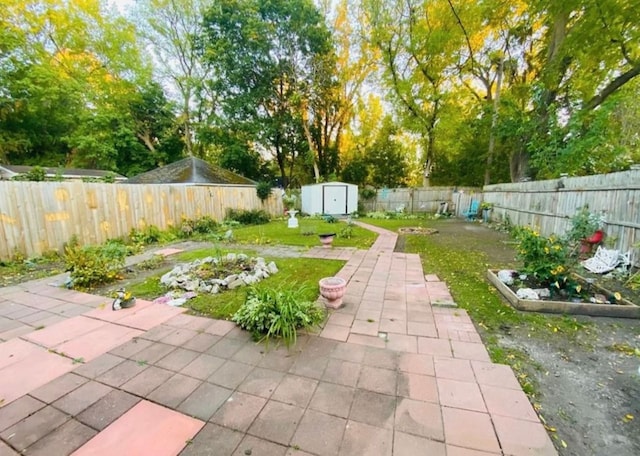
[{"x1": 233, "y1": 217, "x2": 376, "y2": 249}]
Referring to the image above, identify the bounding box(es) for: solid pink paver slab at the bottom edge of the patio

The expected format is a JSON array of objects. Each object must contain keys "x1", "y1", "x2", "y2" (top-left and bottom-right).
[{"x1": 73, "y1": 400, "x2": 204, "y2": 456}]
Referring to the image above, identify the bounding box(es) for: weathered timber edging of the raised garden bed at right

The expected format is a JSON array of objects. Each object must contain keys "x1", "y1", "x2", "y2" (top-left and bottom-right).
[{"x1": 487, "y1": 270, "x2": 640, "y2": 318}]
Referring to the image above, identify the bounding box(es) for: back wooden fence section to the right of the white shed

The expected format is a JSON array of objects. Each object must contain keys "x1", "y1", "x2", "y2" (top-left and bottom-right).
[{"x1": 361, "y1": 187, "x2": 482, "y2": 215}]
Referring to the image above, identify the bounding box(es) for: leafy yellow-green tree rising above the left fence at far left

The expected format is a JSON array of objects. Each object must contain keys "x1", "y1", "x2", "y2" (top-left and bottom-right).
[{"x1": 0, "y1": 0, "x2": 150, "y2": 170}]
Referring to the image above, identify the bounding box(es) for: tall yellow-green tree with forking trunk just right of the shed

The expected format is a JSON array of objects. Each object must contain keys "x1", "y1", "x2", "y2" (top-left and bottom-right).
[{"x1": 364, "y1": 0, "x2": 463, "y2": 186}]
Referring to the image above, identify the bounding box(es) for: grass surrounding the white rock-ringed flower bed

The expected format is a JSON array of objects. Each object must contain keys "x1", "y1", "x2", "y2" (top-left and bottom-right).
[{"x1": 128, "y1": 249, "x2": 345, "y2": 319}]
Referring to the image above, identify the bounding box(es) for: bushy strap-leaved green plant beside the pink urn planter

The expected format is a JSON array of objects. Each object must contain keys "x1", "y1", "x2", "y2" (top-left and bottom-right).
[{"x1": 232, "y1": 287, "x2": 325, "y2": 348}]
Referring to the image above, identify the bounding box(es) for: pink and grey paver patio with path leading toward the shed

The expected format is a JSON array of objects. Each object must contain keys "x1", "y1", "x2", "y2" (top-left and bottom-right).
[{"x1": 0, "y1": 226, "x2": 557, "y2": 456}]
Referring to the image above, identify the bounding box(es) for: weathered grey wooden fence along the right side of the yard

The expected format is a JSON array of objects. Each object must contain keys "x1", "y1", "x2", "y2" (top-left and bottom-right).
[{"x1": 483, "y1": 170, "x2": 640, "y2": 263}]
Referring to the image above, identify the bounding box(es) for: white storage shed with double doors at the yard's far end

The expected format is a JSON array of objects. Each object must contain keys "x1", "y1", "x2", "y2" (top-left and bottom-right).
[{"x1": 300, "y1": 182, "x2": 358, "y2": 215}]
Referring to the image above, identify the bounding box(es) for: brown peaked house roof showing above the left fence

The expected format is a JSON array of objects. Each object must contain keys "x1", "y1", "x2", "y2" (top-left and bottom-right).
[{"x1": 124, "y1": 157, "x2": 256, "y2": 185}]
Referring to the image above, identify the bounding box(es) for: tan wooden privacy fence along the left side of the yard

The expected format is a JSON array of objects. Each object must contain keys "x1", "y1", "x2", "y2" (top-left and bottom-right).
[{"x1": 0, "y1": 181, "x2": 283, "y2": 259}]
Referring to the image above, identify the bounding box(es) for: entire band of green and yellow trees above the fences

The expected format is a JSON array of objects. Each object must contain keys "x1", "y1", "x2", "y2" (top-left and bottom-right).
[{"x1": 0, "y1": 0, "x2": 640, "y2": 187}]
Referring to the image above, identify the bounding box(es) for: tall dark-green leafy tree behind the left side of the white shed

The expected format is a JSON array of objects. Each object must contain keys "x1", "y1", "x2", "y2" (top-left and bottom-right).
[{"x1": 201, "y1": 0, "x2": 332, "y2": 186}]
